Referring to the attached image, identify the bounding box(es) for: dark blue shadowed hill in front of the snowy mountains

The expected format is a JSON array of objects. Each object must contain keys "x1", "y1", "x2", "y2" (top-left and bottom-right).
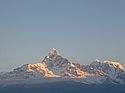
[{"x1": 0, "y1": 81, "x2": 125, "y2": 93}]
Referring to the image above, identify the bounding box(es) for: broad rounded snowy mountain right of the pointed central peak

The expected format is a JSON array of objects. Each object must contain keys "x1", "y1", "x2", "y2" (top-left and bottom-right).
[{"x1": 77, "y1": 60, "x2": 125, "y2": 84}]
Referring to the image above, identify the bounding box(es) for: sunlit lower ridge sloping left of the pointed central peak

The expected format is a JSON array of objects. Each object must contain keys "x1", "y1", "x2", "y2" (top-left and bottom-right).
[{"x1": 0, "y1": 63, "x2": 58, "y2": 79}]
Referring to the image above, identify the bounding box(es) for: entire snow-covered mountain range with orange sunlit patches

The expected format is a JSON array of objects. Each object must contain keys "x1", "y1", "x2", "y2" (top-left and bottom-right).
[{"x1": 0, "y1": 48, "x2": 125, "y2": 85}]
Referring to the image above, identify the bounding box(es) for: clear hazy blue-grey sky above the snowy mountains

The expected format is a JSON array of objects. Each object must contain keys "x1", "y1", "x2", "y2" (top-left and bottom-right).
[{"x1": 0, "y1": 0, "x2": 125, "y2": 72}]
